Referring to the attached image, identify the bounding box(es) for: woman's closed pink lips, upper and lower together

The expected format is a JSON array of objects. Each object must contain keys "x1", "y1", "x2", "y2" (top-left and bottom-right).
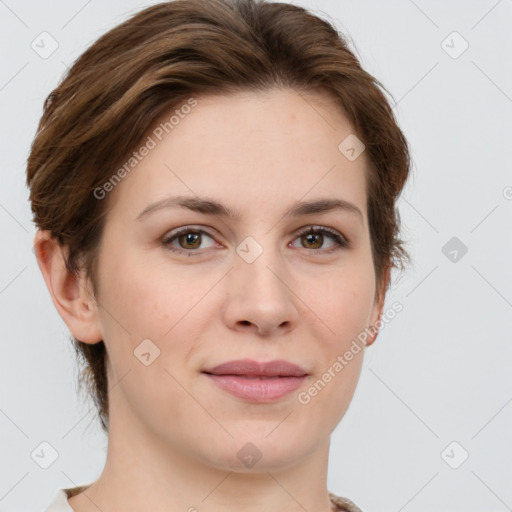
[{"x1": 202, "y1": 359, "x2": 308, "y2": 403}]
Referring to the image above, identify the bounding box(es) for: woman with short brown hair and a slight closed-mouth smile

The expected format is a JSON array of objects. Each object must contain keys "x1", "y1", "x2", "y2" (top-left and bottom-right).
[{"x1": 27, "y1": 0, "x2": 410, "y2": 512}]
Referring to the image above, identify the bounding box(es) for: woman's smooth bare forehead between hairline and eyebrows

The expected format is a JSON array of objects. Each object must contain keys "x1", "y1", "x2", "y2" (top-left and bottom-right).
[{"x1": 106, "y1": 89, "x2": 366, "y2": 222}]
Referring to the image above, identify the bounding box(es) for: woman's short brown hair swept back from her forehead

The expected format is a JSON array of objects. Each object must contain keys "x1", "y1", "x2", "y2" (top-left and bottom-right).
[{"x1": 27, "y1": 0, "x2": 410, "y2": 432}]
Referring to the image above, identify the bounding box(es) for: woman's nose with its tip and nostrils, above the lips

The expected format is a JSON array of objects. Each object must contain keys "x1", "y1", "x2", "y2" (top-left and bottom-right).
[{"x1": 223, "y1": 249, "x2": 299, "y2": 336}]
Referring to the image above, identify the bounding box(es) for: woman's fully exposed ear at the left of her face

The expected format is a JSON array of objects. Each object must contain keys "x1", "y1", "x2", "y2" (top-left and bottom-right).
[{"x1": 34, "y1": 230, "x2": 103, "y2": 344}]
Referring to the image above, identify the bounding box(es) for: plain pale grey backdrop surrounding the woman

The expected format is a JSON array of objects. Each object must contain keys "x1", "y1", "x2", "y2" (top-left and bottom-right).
[{"x1": 0, "y1": 0, "x2": 512, "y2": 512}]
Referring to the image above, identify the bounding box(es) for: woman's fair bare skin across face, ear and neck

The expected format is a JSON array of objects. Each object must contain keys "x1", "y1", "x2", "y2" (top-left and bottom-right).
[{"x1": 35, "y1": 89, "x2": 383, "y2": 512}]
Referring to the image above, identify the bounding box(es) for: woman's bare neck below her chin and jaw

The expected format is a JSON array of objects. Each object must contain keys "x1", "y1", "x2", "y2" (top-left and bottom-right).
[{"x1": 69, "y1": 404, "x2": 340, "y2": 512}]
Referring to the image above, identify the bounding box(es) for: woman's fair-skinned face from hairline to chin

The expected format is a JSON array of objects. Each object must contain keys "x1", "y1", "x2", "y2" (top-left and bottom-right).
[{"x1": 90, "y1": 90, "x2": 380, "y2": 471}]
